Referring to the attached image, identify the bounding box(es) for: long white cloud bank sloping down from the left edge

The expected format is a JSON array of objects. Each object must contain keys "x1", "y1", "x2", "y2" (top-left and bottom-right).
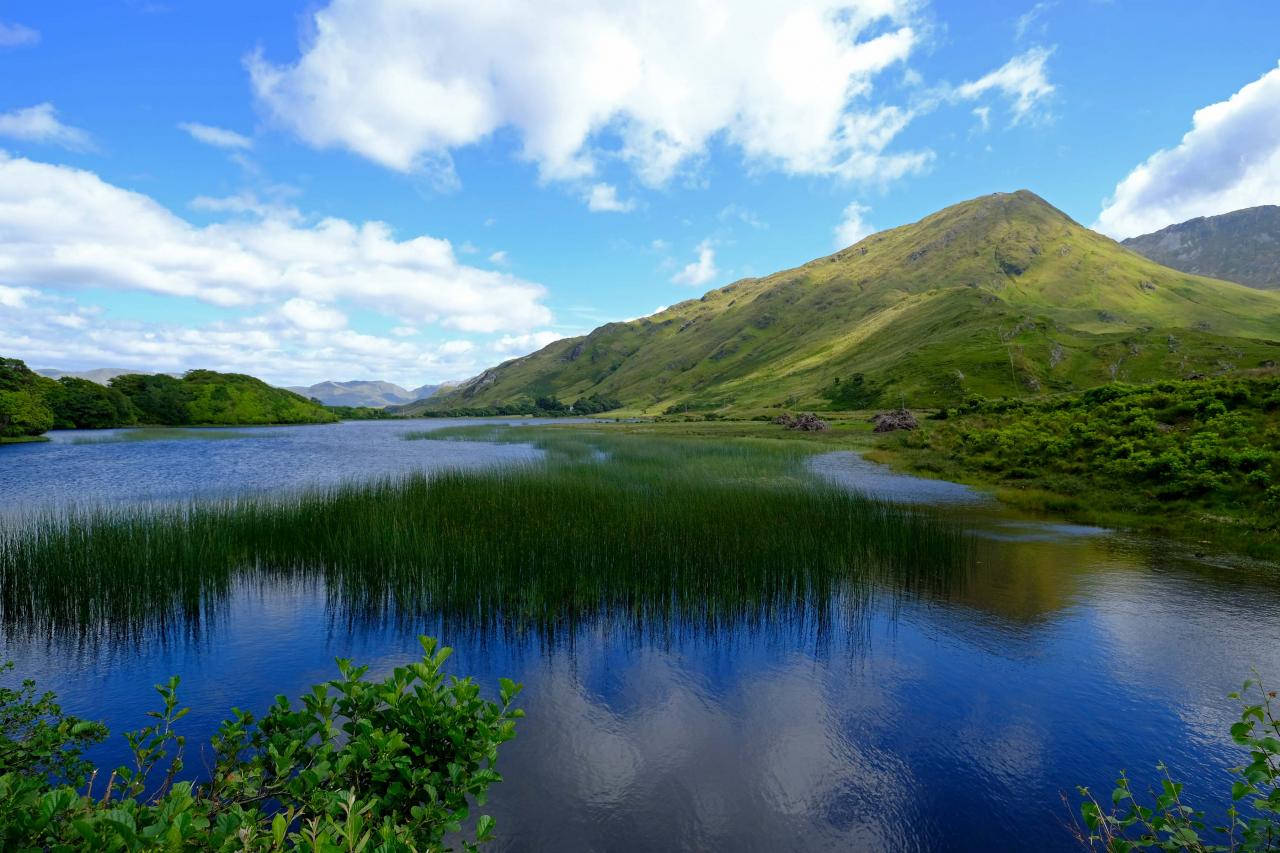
[{"x1": 0, "y1": 152, "x2": 552, "y2": 332}]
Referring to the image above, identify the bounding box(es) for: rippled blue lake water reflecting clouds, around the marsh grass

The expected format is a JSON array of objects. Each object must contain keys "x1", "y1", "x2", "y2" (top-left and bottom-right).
[{"x1": 0, "y1": 421, "x2": 1280, "y2": 850}]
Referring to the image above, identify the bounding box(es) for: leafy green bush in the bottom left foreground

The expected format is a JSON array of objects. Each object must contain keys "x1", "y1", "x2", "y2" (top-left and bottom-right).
[{"x1": 0, "y1": 637, "x2": 524, "y2": 853}]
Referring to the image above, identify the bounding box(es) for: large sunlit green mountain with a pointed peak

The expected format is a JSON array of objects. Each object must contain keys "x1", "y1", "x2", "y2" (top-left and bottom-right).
[{"x1": 406, "y1": 191, "x2": 1280, "y2": 414}]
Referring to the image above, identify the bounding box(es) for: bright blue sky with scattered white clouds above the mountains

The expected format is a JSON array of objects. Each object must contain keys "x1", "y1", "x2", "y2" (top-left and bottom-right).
[{"x1": 0, "y1": 0, "x2": 1280, "y2": 388}]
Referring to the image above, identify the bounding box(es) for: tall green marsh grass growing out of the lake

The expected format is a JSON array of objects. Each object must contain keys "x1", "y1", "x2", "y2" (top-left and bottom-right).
[{"x1": 0, "y1": 428, "x2": 970, "y2": 638}]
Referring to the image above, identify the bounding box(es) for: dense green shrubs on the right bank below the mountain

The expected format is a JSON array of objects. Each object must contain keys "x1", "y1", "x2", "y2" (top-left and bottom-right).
[{"x1": 892, "y1": 375, "x2": 1280, "y2": 545}]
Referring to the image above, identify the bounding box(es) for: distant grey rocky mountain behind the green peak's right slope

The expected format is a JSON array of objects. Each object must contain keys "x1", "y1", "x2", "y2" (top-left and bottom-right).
[{"x1": 1123, "y1": 205, "x2": 1280, "y2": 289}]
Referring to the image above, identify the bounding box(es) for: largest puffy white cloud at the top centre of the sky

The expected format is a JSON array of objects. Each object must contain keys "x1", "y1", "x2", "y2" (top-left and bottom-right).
[{"x1": 247, "y1": 0, "x2": 928, "y2": 186}]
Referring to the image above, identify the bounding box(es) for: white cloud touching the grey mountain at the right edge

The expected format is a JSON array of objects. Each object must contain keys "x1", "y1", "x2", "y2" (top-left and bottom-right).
[{"x1": 1094, "y1": 61, "x2": 1280, "y2": 238}]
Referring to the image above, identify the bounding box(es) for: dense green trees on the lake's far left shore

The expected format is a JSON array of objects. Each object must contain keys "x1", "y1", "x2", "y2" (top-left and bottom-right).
[{"x1": 0, "y1": 359, "x2": 339, "y2": 439}]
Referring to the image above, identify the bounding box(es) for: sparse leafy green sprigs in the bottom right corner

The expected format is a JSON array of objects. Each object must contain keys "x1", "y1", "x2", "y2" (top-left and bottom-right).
[{"x1": 1080, "y1": 679, "x2": 1280, "y2": 853}]
